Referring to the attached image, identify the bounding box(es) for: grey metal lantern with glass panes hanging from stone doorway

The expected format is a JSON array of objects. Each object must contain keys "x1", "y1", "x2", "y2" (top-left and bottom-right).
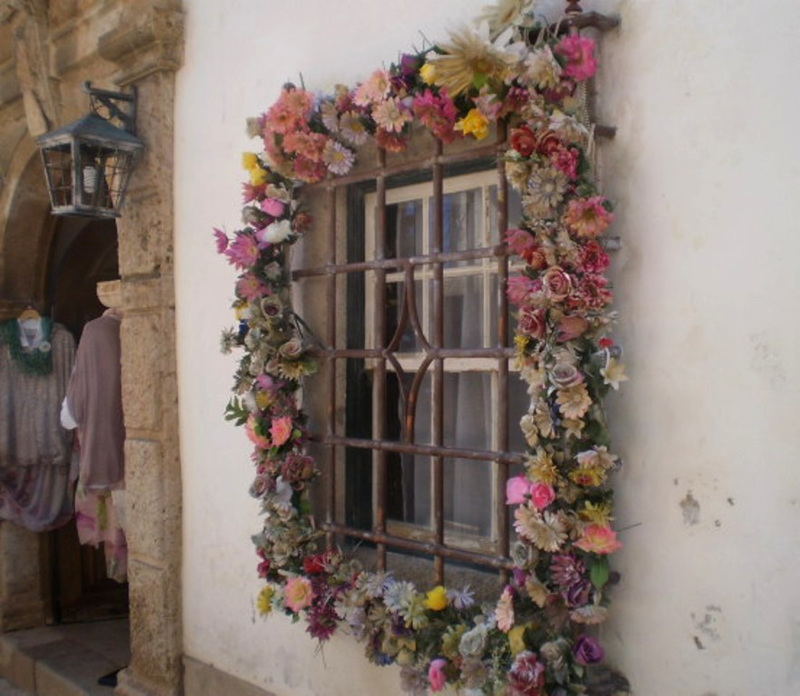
[{"x1": 38, "y1": 82, "x2": 144, "y2": 218}]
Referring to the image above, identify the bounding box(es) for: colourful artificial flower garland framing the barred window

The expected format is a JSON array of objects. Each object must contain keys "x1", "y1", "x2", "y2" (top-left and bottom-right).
[{"x1": 215, "y1": 0, "x2": 627, "y2": 696}]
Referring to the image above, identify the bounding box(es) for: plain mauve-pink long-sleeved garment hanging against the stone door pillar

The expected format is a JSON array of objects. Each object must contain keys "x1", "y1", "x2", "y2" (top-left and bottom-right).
[{"x1": 67, "y1": 314, "x2": 125, "y2": 491}]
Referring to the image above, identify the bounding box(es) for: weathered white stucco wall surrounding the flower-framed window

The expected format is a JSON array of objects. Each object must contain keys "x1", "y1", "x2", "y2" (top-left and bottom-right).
[{"x1": 175, "y1": 0, "x2": 800, "y2": 696}]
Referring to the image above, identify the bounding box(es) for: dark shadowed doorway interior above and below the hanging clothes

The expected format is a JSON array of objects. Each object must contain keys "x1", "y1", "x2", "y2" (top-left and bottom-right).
[{"x1": 44, "y1": 217, "x2": 128, "y2": 623}]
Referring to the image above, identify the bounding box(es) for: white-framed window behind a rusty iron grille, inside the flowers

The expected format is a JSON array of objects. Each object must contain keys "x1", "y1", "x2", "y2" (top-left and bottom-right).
[{"x1": 295, "y1": 136, "x2": 529, "y2": 581}]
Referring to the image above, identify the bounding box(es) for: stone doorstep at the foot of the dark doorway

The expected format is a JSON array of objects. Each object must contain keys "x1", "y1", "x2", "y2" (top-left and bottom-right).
[{"x1": 0, "y1": 620, "x2": 129, "y2": 696}]
